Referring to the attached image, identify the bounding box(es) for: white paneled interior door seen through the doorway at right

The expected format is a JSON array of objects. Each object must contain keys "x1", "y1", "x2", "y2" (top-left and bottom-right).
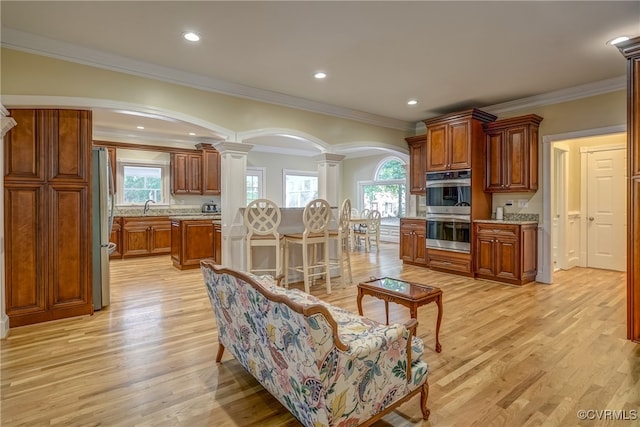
[{"x1": 587, "y1": 149, "x2": 627, "y2": 271}]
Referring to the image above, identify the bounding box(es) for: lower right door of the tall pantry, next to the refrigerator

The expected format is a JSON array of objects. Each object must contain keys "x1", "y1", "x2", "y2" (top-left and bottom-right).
[{"x1": 48, "y1": 184, "x2": 93, "y2": 319}]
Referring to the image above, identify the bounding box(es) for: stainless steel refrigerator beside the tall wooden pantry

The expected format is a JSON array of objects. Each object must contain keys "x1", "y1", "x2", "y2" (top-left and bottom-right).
[{"x1": 91, "y1": 148, "x2": 115, "y2": 310}]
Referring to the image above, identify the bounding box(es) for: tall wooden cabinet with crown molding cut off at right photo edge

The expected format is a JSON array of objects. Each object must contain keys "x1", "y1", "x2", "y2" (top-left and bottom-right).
[{"x1": 617, "y1": 37, "x2": 640, "y2": 343}]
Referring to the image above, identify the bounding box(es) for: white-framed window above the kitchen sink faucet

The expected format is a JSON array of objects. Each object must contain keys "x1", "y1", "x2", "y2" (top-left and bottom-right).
[{"x1": 116, "y1": 160, "x2": 169, "y2": 205}]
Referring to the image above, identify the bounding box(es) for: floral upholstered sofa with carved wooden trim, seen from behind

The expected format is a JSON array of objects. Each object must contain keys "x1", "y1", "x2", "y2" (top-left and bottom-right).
[{"x1": 201, "y1": 261, "x2": 429, "y2": 426}]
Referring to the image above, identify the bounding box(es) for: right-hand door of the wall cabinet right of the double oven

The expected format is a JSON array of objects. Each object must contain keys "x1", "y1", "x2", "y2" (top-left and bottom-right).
[{"x1": 503, "y1": 126, "x2": 529, "y2": 191}]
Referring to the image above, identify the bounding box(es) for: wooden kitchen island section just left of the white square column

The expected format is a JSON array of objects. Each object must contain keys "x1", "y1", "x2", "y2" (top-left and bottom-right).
[{"x1": 169, "y1": 214, "x2": 222, "y2": 270}]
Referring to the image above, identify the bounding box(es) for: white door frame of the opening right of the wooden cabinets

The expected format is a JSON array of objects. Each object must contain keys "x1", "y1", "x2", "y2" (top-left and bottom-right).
[{"x1": 536, "y1": 124, "x2": 627, "y2": 284}]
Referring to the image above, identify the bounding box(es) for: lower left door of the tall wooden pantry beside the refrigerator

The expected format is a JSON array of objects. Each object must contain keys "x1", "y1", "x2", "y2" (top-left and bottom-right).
[{"x1": 4, "y1": 184, "x2": 47, "y2": 320}]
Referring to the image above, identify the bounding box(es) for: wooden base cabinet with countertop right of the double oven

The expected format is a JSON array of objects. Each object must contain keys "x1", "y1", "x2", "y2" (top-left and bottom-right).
[{"x1": 475, "y1": 222, "x2": 538, "y2": 285}]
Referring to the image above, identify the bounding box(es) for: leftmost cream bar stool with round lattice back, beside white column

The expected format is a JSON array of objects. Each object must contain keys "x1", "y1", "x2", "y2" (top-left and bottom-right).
[{"x1": 244, "y1": 199, "x2": 284, "y2": 277}]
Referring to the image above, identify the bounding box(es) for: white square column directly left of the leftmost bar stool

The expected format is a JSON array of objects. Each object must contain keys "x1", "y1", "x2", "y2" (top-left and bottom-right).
[{"x1": 213, "y1": 142, "x2": 253, "y2": 271}]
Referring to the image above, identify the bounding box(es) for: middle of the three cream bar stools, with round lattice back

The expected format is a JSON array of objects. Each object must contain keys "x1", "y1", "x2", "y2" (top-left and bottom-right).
[{"x1": 284, "y1": 199, "x2": 331, "y2": 294}]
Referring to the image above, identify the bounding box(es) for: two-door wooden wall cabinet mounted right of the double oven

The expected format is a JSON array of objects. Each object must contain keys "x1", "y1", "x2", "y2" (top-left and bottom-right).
[{"x1": 484, "y1": 114, "x2": 542, "y2": 193}]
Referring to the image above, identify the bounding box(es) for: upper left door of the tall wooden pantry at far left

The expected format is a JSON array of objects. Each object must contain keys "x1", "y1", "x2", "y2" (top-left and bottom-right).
[{"x1": 4, "y1": 110, "x2": 45, "y2": 182}]
